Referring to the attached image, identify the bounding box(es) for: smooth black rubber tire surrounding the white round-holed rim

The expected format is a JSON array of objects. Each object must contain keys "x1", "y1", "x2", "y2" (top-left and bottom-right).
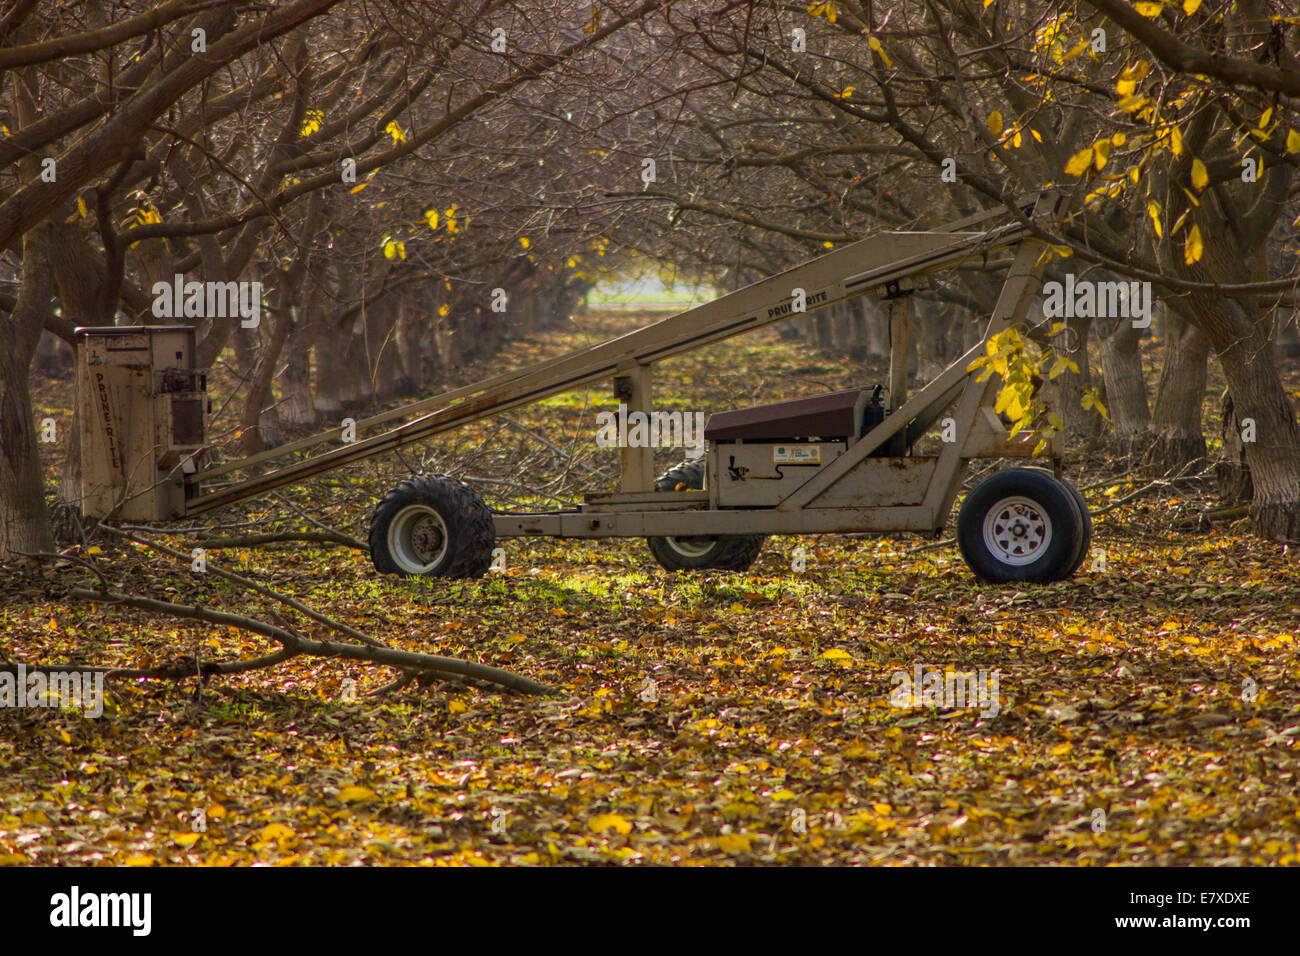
[{"x1": 957, "y1": 468, "x2": 1086, "y2": 584}]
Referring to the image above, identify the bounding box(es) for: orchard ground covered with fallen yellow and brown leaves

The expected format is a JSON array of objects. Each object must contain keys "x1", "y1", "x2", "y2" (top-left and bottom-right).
[{"x1": 0, "y1": 319, "x2": 1300, "y2": 865}]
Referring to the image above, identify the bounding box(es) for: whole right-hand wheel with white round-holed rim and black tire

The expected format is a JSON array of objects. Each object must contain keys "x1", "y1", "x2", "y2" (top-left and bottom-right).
[{"x1": 957, "y1": 468, "x2": 1087, "y2": 584}]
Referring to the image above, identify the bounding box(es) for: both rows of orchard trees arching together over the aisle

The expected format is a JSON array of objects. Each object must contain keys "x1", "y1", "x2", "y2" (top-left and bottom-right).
[{"x1": 0, "y1": 0, "x2": 1300, "y2": 550}]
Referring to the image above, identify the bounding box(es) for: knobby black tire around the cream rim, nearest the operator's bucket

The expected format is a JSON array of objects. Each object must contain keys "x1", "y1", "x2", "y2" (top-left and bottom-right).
[{"x1": 369, "y1": 475, "x2": 497, "y2": 578}]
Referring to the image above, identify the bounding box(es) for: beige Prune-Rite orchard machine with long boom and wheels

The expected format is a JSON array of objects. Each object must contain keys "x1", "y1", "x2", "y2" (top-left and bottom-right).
[{"x1": 77, "y1": 191, "x2": 1092, "y2": 581}]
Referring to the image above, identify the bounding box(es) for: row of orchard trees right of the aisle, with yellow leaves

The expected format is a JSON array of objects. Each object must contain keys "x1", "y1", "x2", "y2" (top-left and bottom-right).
[{"x1": 592, "y1": 0, "x2": 1300, "y2": 538}]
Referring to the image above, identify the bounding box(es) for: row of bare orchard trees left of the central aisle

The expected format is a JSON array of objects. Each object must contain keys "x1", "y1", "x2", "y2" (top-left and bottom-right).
[{"x1": 0, "y1": 0, "x2": 671, "y2": 550}]
